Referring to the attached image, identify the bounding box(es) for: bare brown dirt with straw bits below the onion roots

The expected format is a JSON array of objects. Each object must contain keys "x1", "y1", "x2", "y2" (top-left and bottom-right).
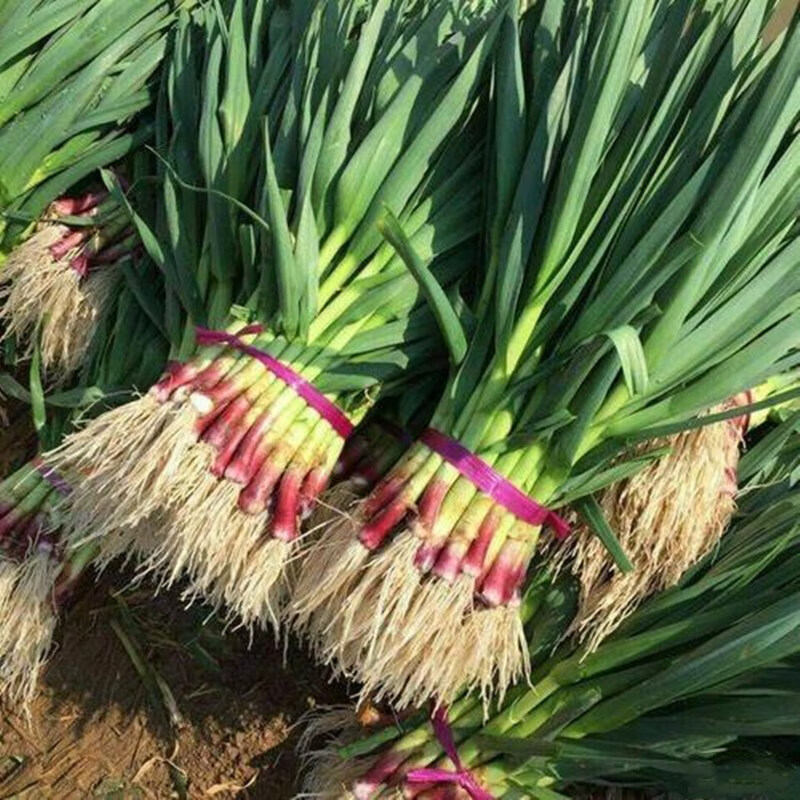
[{"x1": 0, "y1": 576, "x2": 347, "y2": 800}]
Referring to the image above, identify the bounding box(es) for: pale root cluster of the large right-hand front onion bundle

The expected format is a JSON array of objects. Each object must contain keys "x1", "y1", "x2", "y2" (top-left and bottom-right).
[{"x1": 291, "y1": 510, "x2": 530, "y2": 708}]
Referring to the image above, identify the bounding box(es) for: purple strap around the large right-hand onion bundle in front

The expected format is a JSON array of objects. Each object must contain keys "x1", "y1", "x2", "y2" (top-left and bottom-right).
[{"x1": 420, "y1": 428, "x2": 569, "y2": 539}]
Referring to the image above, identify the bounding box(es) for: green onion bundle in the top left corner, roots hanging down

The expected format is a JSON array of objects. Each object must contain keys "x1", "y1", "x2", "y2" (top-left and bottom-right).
[{"x1": 0, "y1": 0, "x2": 193, "y2": 385}]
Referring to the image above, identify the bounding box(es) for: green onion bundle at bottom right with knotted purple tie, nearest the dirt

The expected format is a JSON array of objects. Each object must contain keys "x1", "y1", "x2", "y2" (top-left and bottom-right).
[{"x1": 305, "y1": 413, "x2": 800, "y2": 800}]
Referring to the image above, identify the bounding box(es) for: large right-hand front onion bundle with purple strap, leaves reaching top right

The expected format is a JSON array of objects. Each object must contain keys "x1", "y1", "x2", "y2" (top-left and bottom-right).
[{"x1": 292, "y1": 2, "x2": 800, "y2": 705}]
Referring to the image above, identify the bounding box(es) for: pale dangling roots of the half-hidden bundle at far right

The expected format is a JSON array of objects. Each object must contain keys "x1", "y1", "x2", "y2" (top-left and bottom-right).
[{"x1": 553, "y1": 422, "x2": 739, "y2": 651}]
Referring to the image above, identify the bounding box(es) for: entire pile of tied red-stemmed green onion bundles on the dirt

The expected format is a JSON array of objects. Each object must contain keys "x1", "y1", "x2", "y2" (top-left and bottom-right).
[{"x1": 0, "y1": 0, "x2": 800, "y2": 800}]
